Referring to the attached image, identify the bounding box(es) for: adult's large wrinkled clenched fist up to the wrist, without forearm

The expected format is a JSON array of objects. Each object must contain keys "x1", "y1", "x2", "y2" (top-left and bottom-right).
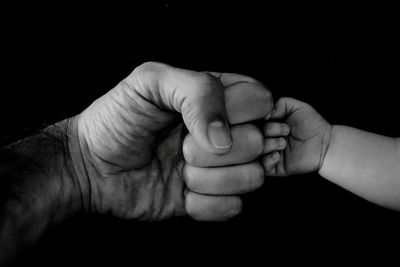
[{"x1": 71, "y1": 63, "x2": 273, "y2": 220}]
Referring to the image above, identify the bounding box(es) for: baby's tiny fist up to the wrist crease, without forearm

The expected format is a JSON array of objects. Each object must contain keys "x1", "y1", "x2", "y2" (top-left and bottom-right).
[{"x1": 263, "y1": 98, "x2": 332, "y2": 176}]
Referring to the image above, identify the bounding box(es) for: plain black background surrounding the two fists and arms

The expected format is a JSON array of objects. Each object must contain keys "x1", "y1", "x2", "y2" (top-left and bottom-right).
[{"x1": 0, "y1": 1, "x2": 400, "y2": 266}]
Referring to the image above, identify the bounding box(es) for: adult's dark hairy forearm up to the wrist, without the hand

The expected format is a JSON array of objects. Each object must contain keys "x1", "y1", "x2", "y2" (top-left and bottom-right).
[{"x1": 0, "y1": 120, "x2": 86, "y2": 262}]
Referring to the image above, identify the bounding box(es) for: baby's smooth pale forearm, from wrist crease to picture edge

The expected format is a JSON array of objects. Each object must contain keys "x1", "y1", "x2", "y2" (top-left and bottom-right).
[{"x1": 319, "y1": 125, "x2": 400, "y2": 210}]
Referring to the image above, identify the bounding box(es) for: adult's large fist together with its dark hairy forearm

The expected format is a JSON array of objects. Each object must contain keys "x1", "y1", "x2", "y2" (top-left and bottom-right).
[{"x1": 0, "y1": 62, "x2": 282, "y2": 265}]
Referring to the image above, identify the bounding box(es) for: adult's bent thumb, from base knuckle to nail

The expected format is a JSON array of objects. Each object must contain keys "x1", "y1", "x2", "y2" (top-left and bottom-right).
[{"x1": 133, "y1": 62, "x2": 232, "y2": 154}]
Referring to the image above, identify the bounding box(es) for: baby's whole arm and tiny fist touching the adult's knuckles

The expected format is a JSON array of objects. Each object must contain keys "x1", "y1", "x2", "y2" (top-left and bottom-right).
[{"x1": 263, "y1": 97, "x2": 400, "y2": 211}]
